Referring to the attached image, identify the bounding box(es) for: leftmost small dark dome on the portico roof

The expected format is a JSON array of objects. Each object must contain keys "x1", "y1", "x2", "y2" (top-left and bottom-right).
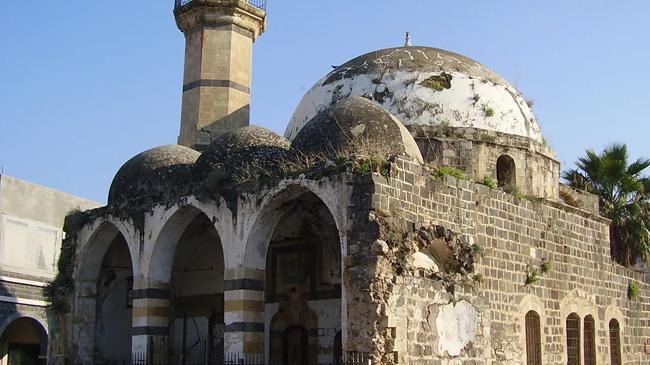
[{"x1": 108, "y1": 145, "x2": 200, "y2": 205}]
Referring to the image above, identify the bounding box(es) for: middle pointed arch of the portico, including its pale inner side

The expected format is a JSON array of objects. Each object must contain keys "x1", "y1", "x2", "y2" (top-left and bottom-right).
[{"x1": 144, "y1": 204, "x2": 225, "y2": 354}]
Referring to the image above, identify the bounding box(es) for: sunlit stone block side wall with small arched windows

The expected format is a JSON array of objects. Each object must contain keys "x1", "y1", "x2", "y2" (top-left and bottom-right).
[{"x1": 364, "y1": 160, "x2": 650, "y2": 364}]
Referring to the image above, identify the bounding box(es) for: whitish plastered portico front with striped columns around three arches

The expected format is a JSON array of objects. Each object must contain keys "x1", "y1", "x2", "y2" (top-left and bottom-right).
[{"x1": 62, "y1": 177, "x2": 350, "y2": 361}]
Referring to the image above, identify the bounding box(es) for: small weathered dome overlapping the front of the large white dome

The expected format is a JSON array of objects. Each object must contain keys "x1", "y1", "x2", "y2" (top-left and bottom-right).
[{"x1": 291, "y1": 96, "x2": 422, "y2": 163}]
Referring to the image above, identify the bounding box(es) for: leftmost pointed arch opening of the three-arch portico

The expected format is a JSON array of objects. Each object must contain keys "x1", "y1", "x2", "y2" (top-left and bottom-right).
[{"x1": 74, "y1": 223, "x2": 133, "y2": 363}]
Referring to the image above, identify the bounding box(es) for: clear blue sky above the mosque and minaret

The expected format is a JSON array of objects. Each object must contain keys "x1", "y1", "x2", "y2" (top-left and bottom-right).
[{"x1": 0, "y1": 0, "x2": 650, "y2": 201}]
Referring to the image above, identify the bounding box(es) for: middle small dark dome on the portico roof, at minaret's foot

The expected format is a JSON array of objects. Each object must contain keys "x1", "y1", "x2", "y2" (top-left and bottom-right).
[{"x1": 195, "y1": 126, "x2": 290, "y2": 176}]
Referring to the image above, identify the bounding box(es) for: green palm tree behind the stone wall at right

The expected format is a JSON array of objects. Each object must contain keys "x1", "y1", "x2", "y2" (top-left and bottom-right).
[{"x1": 562, "y1": 144, "x2": 650, "y2": 266}]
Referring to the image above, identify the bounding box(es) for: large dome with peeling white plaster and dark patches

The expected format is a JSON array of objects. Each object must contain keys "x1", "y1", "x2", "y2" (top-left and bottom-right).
[{"x1": 285, "y1": 47, "x2": 543, "y2": 142}]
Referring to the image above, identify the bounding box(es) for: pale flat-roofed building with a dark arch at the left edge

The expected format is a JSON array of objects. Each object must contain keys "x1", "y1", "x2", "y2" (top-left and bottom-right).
[{"x1": 0, "y1": 175, "x2": 99, "y2": 365}]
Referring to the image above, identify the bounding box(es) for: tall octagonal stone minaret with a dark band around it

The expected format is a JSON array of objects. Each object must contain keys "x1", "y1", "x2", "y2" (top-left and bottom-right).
[{"x1": 174, "y1": 0, "x2": 266, "y2": 150}]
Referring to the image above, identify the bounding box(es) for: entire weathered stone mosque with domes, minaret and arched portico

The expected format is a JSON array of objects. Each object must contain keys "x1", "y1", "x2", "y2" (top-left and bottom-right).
[{"x1": 49, "y1": 0, "x2": 650, "y2": 365}]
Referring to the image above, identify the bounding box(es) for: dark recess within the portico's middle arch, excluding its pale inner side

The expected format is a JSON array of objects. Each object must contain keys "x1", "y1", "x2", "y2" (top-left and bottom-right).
[{"x1": 163, "y1": 210, "x2": 224, "y2": 361}]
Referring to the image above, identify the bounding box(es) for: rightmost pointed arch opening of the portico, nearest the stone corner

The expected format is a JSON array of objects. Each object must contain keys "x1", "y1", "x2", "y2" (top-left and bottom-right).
[{"x1": 244, "y1": 184, "x2": 345, "y2": 362}]
